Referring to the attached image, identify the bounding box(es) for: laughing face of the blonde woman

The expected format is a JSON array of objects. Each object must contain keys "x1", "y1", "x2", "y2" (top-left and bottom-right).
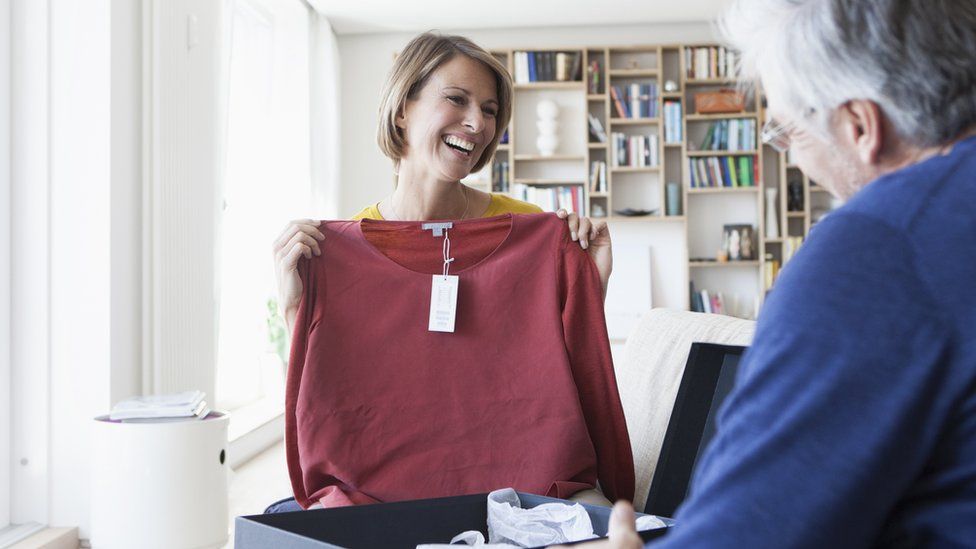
[{"x1": 397, "y1": 55, "x2": 498, "y2": 181}]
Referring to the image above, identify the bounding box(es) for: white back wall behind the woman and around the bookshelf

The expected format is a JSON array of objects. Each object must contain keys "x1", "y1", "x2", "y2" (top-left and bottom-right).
[{"x1": 338, "y1": 22, "x2": 716, "y2": 312}]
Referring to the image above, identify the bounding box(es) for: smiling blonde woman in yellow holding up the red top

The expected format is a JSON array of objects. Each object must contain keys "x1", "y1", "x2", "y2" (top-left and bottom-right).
[{"x1": 274, "y1": 32, "x2": 612, "y2": 336}]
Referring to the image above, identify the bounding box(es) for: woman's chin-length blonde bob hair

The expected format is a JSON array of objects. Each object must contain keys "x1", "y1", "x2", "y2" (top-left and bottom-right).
[{"x1": 376, "y1": 32, "x2": 512, "y2": 172}]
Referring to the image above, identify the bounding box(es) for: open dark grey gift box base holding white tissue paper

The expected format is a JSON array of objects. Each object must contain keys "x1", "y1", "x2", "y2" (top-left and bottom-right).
[{"x1": 234, "y1": 492, "x2": 670, "y2": 549}]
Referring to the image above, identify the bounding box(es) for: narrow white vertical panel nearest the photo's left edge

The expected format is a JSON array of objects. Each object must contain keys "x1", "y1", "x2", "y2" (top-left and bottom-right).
[{"x1": 10, "y1": 0, "x2": 51, "y2": 524}]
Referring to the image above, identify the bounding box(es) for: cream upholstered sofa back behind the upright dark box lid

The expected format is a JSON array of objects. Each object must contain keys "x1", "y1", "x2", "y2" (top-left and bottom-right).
[{"x1": 615, "y1": 309, "x2": 755, "y2": 510}]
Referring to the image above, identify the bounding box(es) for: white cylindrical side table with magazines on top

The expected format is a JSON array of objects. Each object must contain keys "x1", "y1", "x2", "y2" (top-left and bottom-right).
[{"x1": 91, "y1": 412, "x2": 229, "y2": 549}]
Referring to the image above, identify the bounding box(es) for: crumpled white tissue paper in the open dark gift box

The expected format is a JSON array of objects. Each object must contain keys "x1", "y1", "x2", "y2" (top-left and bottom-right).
[{"x1": 417, "y1": 488, "x2": 667, "y2": 549}]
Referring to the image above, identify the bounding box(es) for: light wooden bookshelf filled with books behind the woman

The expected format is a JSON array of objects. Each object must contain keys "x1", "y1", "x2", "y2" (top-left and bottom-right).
[{"x1": 466, "y1": 43, "x2": 816, "y2": 317}]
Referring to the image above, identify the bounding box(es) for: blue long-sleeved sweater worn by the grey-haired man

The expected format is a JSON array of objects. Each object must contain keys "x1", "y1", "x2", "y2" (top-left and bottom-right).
[{"x1": 660, "y1": 138, "x2": 976, "y2": 548}]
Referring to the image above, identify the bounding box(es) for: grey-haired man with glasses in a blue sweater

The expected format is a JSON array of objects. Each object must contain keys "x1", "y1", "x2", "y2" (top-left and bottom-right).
[{"x1": 580, "y1": 0, "x2": 976, "y2": 547}]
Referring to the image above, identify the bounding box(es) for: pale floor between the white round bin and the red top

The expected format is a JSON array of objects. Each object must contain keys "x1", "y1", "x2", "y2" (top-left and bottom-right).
[{"x1": 224, "y1": 442, "x2": 291, "y2": 549}]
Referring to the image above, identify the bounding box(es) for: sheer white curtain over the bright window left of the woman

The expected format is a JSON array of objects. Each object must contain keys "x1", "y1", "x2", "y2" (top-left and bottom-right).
[{"x1": 216, "y1": 0, "x2": 312, "y2": 432}]
